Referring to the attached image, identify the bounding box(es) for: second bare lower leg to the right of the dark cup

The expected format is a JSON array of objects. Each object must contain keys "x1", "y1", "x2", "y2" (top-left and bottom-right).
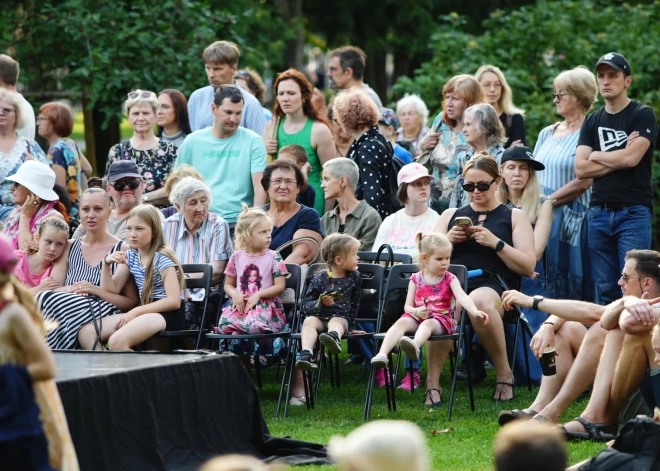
[{"x1": 534, "y1": 322, "x2": 607, "y2": 423}]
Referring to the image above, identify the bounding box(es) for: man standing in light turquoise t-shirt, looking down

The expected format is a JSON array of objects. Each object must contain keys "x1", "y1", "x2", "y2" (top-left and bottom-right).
[{"x1": 175, "y1": 85, "x2": 267, "y2": 236}]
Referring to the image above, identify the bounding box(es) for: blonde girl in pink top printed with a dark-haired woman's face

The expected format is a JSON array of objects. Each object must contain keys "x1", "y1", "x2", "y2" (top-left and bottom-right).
[{"x1": 218, "y1": 207, "x2": 288, "y2": 334}]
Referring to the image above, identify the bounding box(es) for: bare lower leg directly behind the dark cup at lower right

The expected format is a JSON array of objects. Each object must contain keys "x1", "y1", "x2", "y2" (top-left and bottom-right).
[{"x1": 529, "y1": 322, "x2": 587, "y2": 411}]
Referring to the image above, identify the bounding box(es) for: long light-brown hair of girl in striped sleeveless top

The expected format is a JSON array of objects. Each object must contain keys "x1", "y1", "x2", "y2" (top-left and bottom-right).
[{"x1": 126, "y1": 204, "x2": 185, "y2": 304}]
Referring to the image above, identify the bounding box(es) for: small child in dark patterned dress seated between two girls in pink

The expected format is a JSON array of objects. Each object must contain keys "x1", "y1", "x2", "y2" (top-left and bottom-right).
[{"x1": 296, "y1": 234, "x2": 362, "y2": 370}]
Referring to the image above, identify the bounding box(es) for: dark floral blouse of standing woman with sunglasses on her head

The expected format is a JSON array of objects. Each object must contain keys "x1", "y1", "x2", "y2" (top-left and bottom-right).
[{"x1": 105, "y1": 139, "x2": 179, "y2": 193}]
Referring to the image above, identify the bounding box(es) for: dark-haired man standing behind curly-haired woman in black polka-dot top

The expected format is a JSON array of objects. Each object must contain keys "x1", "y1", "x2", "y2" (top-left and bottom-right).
[{"x1": 328, "y1": 46, "x2": 383, "y2": 108}]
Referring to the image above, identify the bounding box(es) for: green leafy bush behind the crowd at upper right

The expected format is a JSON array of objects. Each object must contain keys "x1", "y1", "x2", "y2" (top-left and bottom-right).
[{"x1": 394, "y1": 0, "x2": 660, "y2": 247}]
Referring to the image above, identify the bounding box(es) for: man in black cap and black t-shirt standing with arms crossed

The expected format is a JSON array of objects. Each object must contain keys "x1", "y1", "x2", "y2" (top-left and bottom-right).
[{"x1": 575, "y1": 52, "x2": 658, "y2": 304}]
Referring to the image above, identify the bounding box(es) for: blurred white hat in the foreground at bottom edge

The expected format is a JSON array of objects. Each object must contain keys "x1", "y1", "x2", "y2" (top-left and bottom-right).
[{"x1": 328, "y1": 420, "x2": 431, "y2": 471}]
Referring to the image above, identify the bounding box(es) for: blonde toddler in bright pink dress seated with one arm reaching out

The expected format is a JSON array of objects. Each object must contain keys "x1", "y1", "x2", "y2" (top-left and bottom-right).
[{"x1": 371, "y1": 232, "x2": 488, "y2": 407}]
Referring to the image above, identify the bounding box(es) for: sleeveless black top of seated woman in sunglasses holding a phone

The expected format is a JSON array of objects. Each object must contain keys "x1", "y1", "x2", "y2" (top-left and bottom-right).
[{"x1": 447, "y1": 204, "x2": 520, "y2": 289}]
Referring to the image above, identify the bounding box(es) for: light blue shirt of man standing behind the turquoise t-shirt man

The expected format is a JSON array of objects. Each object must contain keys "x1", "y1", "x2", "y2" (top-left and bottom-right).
[{"x1": 188, "y1": 83, "x2": 266, "y2": 136}]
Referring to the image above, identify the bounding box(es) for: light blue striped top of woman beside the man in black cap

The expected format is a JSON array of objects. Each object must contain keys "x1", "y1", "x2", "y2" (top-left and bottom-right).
[{"x1": 534, "y1": 124, "x2": 591, "y2": 210}]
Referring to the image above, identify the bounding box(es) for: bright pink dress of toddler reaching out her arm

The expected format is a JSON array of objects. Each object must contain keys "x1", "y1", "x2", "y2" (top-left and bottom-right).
[{"x1": 402, "y1": 271, "x2": 456, "y2": 333}]
